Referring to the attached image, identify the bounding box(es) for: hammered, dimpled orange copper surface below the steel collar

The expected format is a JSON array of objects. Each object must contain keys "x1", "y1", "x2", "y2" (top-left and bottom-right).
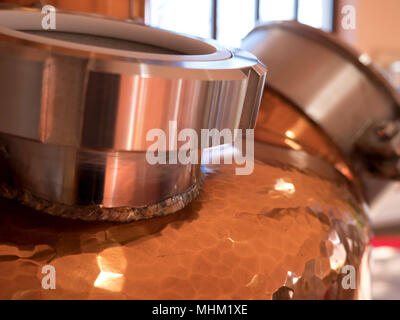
[{"x1": 0, "y1": 140, "x2": 369, "y2": 299}]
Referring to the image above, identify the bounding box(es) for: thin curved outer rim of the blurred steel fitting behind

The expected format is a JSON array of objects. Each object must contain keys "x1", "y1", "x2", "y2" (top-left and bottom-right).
[{"x1": 246, "y1": 20, "x2": 400, "y2": 112}]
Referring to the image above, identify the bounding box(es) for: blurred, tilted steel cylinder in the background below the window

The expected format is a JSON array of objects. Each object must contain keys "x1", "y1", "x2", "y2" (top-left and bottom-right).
[{"x1": 242, "y1": 21, "x2": 400, "y2": 153}]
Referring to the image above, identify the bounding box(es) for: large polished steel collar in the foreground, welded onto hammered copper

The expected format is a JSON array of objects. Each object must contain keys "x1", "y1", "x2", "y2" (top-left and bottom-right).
[{"x1": 0, "y1": 10, "x2": 266, "y2": 220}]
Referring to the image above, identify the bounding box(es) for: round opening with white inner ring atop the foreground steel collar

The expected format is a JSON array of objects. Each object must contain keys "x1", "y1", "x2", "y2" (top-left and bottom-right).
[{"x1": 0, "y1": 10, "x2": 231, "y2": 60}]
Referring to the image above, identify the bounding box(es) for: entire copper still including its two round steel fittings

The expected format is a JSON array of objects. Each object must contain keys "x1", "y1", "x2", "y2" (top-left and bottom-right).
[{"x1": 0, "y1": 5, "x2": 398, "y2": 299}]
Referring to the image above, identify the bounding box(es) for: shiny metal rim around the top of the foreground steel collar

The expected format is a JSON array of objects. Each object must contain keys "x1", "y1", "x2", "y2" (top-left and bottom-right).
[{"x1": 0, "y1": 8, "x2": 266, "y2": 76}]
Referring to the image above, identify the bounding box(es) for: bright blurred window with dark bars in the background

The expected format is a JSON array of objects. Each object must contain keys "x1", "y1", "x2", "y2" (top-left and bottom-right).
[{"x1": 150, "y1": 0, "x2": 334, "y2": 47}]
